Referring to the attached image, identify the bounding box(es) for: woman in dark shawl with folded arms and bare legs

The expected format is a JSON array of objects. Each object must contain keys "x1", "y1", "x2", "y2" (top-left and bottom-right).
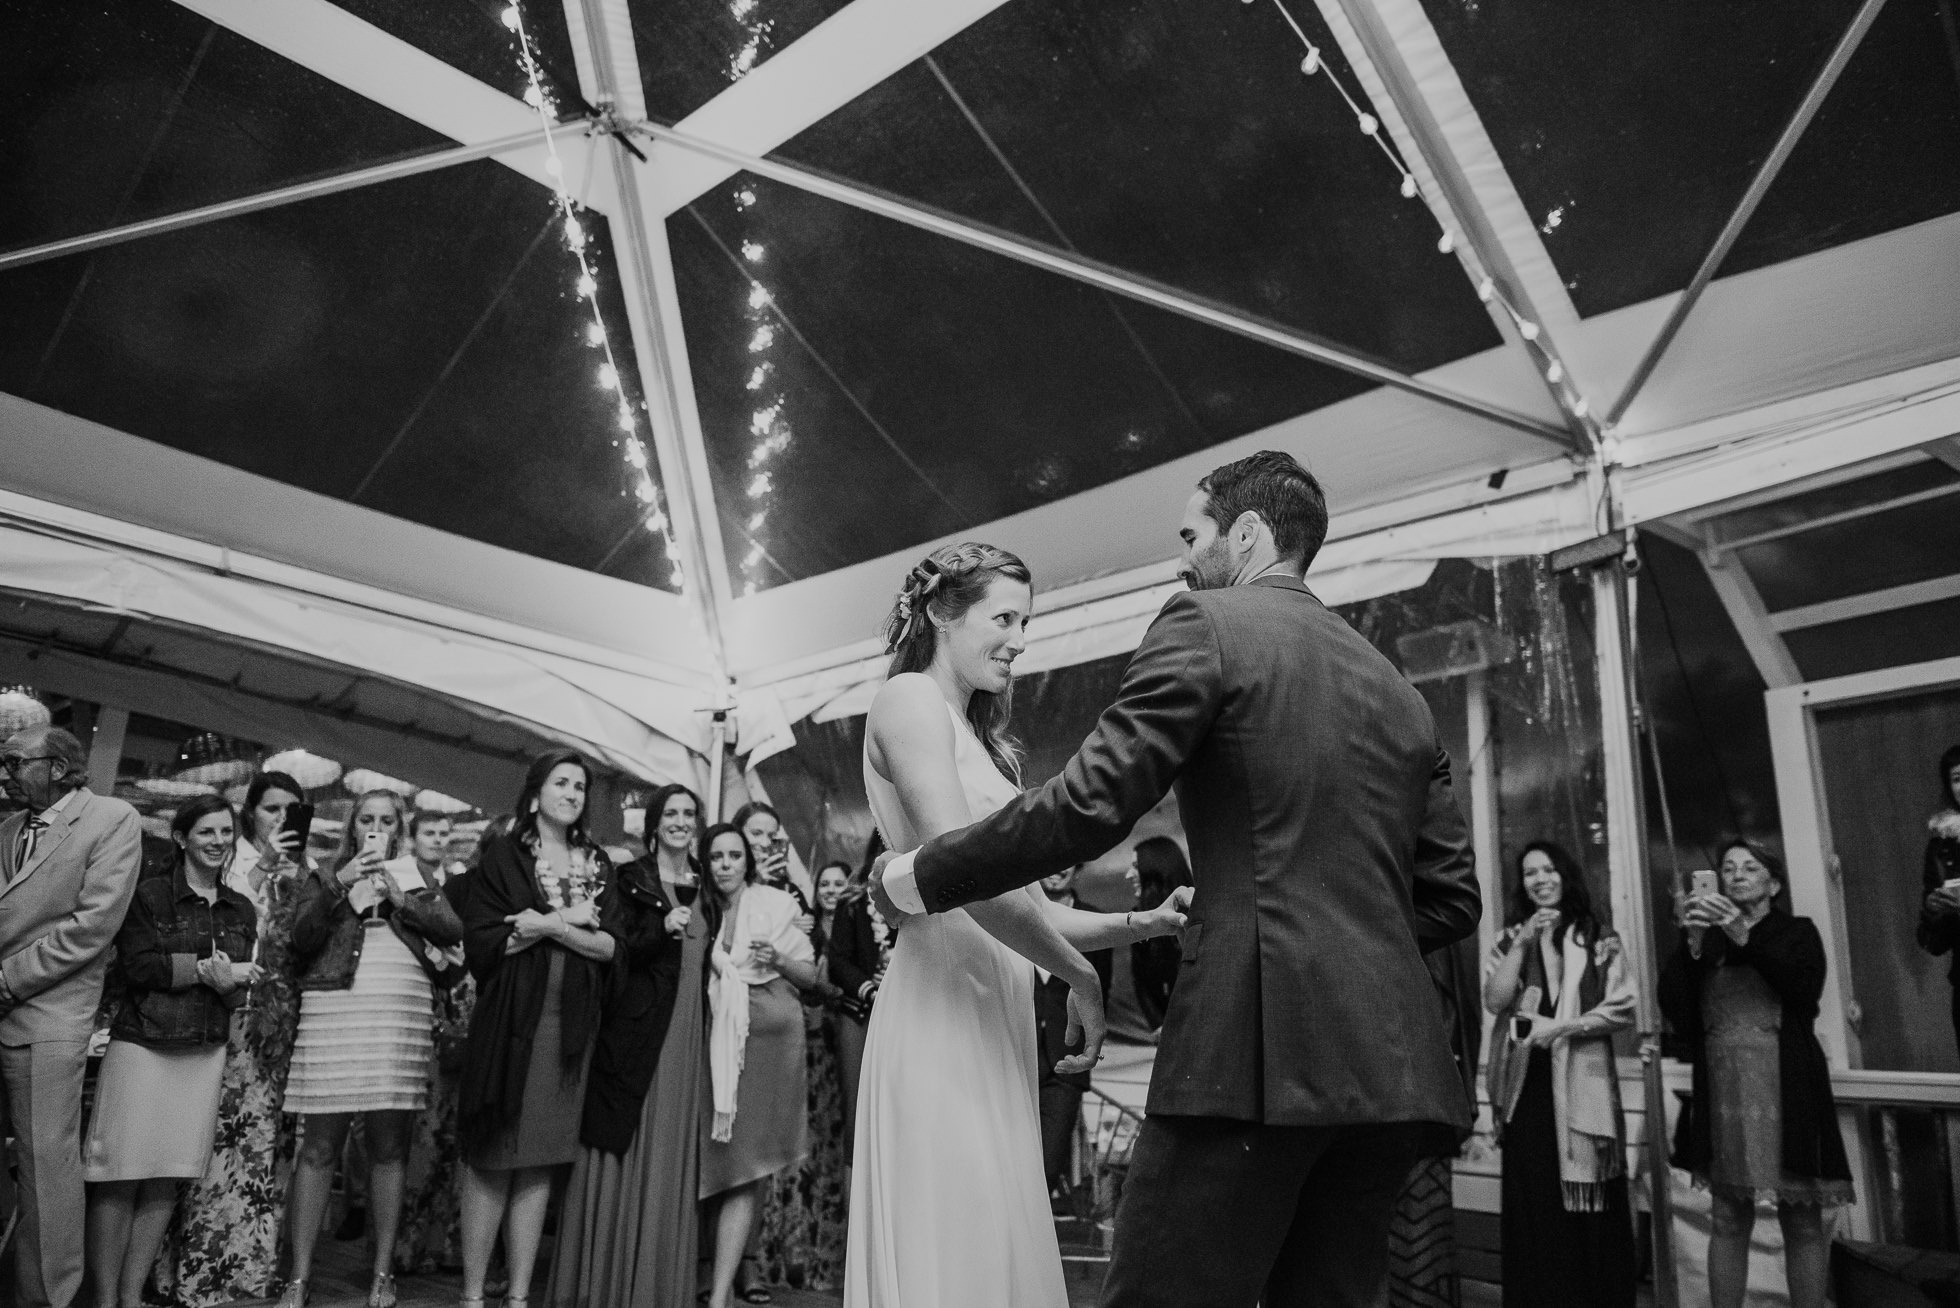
[{"x1": 457, "y1": 749, "x2": 617, "y2": 1308}]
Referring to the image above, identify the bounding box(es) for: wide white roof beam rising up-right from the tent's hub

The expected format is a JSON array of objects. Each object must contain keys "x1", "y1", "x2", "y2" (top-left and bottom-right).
[{"x1": 642, "y1": 0, "x2": 1005, "y2": 218}]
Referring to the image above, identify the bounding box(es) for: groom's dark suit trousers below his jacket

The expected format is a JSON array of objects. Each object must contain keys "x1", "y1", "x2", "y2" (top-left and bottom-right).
[{"x1": 1102, "y1": 1116, "x2": 1423, "y2": 1308}]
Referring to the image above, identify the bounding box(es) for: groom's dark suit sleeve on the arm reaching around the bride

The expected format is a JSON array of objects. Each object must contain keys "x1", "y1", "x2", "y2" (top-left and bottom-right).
[{"x1": 913, "y1": 594, "x2": 1223, "y2": 912}]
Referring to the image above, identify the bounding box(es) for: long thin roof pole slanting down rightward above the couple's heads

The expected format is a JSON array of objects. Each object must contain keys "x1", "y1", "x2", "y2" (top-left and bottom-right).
[{"x1": 635, "y1": 122, "x2": 1572, "y2": 453}]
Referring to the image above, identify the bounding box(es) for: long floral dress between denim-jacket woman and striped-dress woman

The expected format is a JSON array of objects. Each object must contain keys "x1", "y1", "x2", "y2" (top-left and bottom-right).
[{"x1": 155, "y1": 845, "x2": 300, "y2": 1308}]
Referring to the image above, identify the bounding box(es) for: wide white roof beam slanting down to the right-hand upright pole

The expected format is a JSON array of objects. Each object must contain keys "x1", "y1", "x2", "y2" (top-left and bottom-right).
[{"x1": 1317, "y1": 0, "x2": 1599, "y2": 455}]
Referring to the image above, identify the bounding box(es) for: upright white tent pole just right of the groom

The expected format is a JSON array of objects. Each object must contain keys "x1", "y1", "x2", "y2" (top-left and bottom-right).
[{"x1": 1592, "y1": 470, "x2": 1680, "y2": 1308}]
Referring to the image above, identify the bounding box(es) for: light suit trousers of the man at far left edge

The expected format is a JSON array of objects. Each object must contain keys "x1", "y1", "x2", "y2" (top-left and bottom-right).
[{"x1": 0, "y1": 1039, "x2": 88, "y2": 1308}]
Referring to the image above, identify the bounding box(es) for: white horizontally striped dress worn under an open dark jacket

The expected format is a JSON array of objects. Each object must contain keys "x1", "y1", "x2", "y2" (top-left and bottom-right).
[{"x1": 286, "y1": 920, "x2": 435, "y2": 1114}]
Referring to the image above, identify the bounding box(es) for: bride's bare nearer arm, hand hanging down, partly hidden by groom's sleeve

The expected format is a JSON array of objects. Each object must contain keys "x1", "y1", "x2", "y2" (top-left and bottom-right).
[{"x1": 864, "y1": 673, "x2": 1103, "y2": 1073}]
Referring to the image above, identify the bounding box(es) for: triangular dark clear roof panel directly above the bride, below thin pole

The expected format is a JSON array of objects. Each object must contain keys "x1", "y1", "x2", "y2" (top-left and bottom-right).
[{"x1": 668, "y1": 175, "x2": 1395, "y2": 590}]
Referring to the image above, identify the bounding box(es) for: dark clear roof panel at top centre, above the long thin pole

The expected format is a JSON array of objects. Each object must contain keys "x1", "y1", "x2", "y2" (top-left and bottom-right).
[{"x1": 774, "y1": 0, "x2": 1501, "y2": 373}]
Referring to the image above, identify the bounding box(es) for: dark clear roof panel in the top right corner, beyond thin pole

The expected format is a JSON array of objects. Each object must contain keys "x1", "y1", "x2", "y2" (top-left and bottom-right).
[{"x1": 1719, "y1": 0, "x2": 1960, "y2": 290}]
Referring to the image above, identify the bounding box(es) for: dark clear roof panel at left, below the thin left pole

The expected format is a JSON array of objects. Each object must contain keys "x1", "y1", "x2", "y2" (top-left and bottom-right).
[{"x1": 0, "y1": 161, "x2": 668, "y2": 600}]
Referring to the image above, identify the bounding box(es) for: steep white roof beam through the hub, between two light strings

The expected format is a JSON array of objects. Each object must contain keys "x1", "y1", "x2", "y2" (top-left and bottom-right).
[{"x1": 564, "y1": 0, "x2": 733, "y2": 679}]
